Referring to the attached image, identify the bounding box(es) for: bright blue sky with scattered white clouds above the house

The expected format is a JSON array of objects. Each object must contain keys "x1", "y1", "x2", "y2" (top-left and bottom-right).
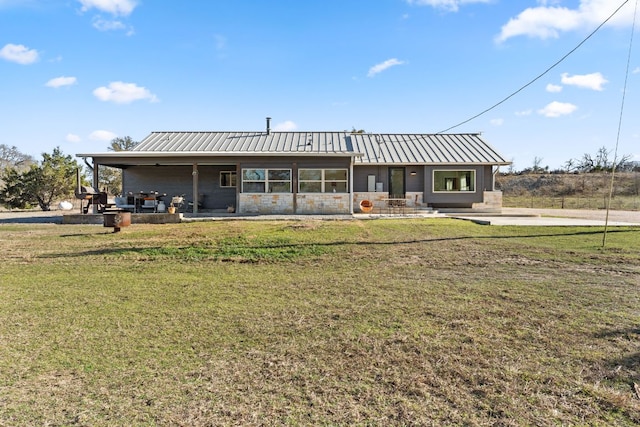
[{"x1": 0, "y1": 0, "x2": 640, "y2": 170}]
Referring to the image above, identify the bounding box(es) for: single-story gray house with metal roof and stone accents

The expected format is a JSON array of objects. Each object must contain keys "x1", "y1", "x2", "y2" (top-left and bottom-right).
[{"x1": 76, "y1": 119, "x2": 510, "y2": 214}]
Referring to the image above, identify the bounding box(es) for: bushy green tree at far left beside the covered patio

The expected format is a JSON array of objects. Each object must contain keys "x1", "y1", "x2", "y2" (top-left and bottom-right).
[{"x1": 0, "y1": 147, "x2": 79, "y2": 211}]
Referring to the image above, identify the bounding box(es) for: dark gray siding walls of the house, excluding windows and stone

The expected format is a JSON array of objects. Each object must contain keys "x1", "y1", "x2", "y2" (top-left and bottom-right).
[{"x1": 116, "y1": 156, "x2": 500, "y2": 213}]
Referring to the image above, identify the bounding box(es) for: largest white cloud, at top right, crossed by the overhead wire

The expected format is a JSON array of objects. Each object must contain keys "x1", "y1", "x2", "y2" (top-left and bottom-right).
[{"x1": 496, "y1": 0, "x2": 634, "y2": 43}]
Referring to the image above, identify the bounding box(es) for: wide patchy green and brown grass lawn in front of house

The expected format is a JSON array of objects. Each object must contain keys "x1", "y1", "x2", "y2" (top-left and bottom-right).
[{"x1": 0, "y1": 219, "x2": 640, "y2": 426}]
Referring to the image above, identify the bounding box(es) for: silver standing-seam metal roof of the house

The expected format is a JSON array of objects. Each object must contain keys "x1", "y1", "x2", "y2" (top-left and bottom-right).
[{"x1": 129, "y1": 131, "x2": 510, "y2": 165}]
